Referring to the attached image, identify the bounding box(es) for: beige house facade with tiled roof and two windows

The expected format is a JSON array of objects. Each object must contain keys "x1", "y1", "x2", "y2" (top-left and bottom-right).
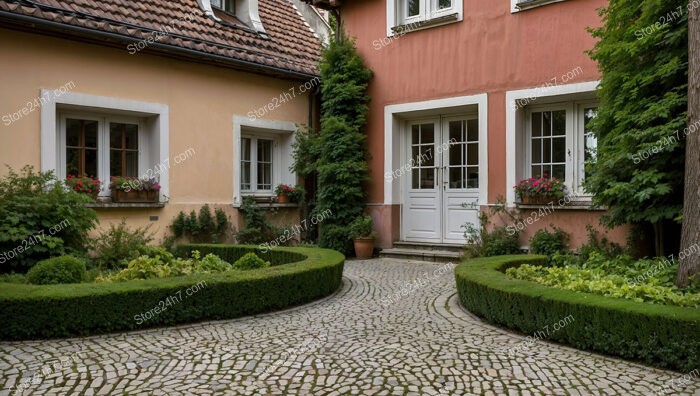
[{"x1": 0, "y1": 0, "x2": 327, "y2": 236}]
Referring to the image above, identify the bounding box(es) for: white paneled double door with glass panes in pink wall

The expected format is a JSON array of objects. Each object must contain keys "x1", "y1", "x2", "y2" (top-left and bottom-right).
[{"x1": 402, "y1": 116, "x2": 480, "y2": 244}]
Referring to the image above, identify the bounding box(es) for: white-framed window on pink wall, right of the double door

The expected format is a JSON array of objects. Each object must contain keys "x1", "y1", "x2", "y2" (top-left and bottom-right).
[{"x1": 525, "y1": 102, "x2": 598, "y2": 193}]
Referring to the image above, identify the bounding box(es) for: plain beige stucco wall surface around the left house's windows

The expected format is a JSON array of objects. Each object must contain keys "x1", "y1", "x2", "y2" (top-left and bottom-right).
[{"x1": 0, "y1": 29, "x2": 309, "y2": 238}]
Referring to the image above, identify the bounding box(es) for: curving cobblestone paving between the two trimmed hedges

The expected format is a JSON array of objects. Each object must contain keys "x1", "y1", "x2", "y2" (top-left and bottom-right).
[{"x1": 0, "y1": 259, "x2": 700, "y2": 395}]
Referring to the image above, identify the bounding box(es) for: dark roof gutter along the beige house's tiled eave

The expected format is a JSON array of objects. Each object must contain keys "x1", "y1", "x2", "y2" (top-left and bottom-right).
[{"x1": 0, "y1": 10, "x2": 318, "y2": 81}]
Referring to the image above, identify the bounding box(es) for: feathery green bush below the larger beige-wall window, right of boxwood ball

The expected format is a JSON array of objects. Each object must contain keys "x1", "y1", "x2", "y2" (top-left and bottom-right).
[{"x1": 92, "y1": 218, "x2": 153, "y2": 270}]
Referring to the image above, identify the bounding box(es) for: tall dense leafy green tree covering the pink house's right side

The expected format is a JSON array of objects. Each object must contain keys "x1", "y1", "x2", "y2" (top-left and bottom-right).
[{"x1": 585, "y1": 0, "x2": 688, "y2": 254}]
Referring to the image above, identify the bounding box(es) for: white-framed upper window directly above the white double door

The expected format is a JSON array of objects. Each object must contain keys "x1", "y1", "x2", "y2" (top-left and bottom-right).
[{"x1": 387, "y1": 0, "x2": 463, "y2": 36}]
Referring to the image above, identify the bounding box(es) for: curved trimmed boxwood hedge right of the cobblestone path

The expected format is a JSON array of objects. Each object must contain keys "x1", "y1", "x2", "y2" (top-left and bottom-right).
[{"x1": 455, "y1": 255, "x2": 700, "y2": 372}]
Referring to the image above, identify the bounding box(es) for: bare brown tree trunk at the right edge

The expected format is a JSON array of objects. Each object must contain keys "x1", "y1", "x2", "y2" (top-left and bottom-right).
[{"x1": 676, "y1": 0, "x2": 700, "y2": 286}]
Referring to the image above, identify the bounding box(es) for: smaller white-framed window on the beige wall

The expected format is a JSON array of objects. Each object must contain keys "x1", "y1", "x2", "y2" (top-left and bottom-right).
[{"x1": 240, "y1": 135, "x2": 279, "y2": 195}]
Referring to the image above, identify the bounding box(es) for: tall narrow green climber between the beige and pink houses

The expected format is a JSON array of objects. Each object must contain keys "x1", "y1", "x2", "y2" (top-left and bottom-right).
[{"x1": 315, "y1": 35, "x2": 372, "y2": 253}]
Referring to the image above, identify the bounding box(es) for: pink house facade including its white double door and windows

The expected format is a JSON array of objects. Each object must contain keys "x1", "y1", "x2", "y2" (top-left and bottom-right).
[{"x1": 311, "y1": 0, "x2": 626, "y2": 247}]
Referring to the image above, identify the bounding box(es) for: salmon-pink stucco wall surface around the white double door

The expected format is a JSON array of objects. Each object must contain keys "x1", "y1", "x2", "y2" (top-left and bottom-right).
[{"x1": 342, "y1": 0, "x2": 625, "y2": 247}]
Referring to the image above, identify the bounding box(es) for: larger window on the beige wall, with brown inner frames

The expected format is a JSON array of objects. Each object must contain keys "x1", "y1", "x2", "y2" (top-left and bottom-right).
[{"x1": 57, "y1": 112, "x2": 150, "y2": 190}]
